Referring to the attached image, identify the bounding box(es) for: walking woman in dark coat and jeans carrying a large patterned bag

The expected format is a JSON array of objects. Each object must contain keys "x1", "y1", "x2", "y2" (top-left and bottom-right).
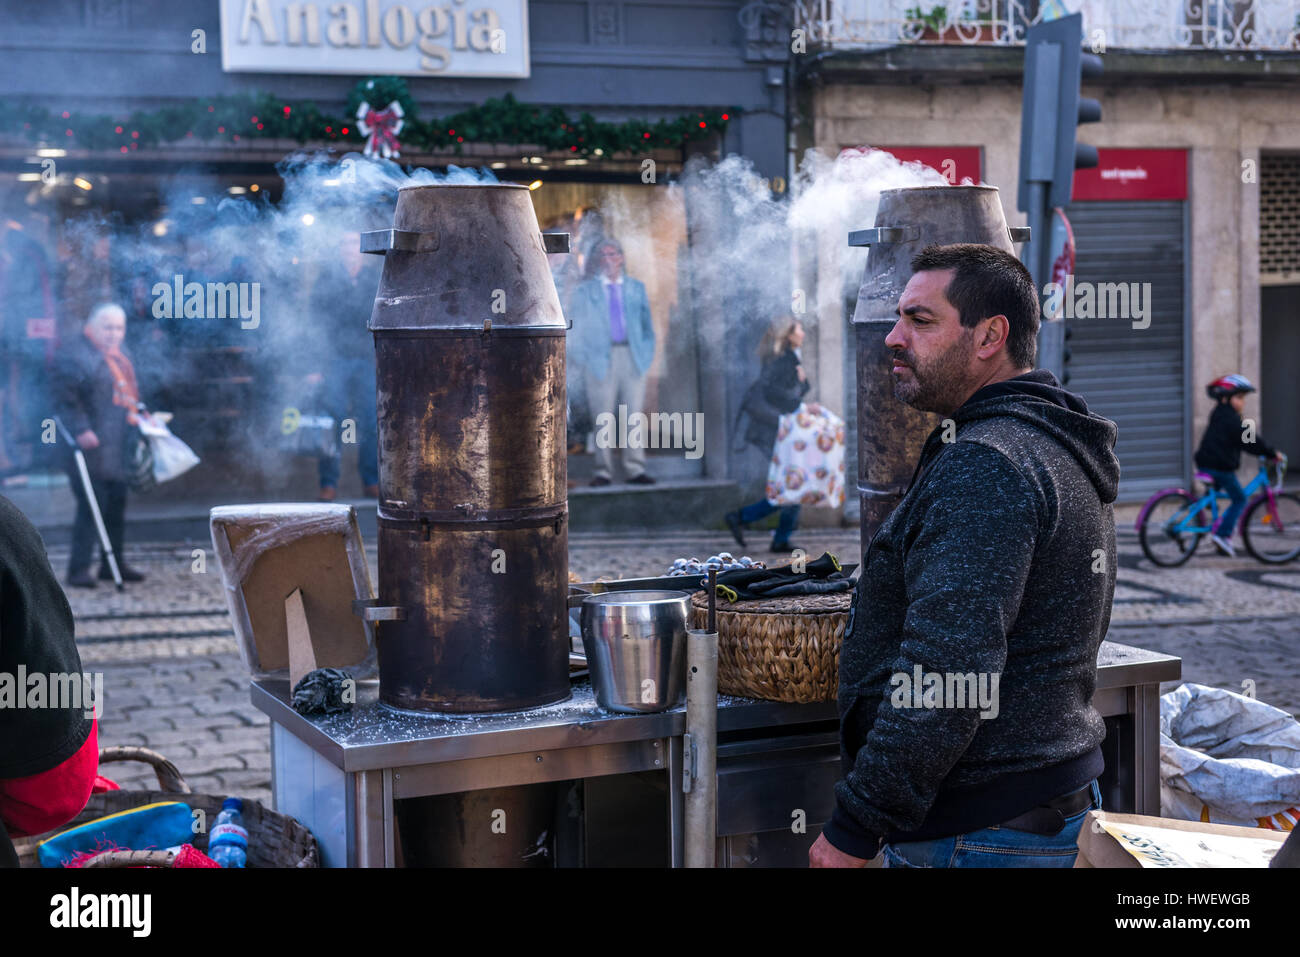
[{"x1": 724, "y1": 316, "x2": 811, "y2": 551}]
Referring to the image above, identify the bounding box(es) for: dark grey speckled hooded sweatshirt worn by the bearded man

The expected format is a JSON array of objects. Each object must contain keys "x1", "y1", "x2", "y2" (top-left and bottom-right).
[{"x1": 824, "y1": 371, "x2": 1119, "y2": 858}]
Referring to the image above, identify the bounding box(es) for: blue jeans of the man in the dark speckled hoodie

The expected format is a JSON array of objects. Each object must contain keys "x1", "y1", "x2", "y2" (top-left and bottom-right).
[{"x1": 881, "y1": 781, "x2": 1101, "y2": 867}]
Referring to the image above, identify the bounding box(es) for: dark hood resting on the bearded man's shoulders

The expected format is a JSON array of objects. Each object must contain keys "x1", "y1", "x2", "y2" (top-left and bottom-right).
[{"x1": 953, "y1": 369, "x2": 1119, "y2": 505}]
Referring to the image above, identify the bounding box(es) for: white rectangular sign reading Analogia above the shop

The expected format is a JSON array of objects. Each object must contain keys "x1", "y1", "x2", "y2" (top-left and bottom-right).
[{"x1": 220, "y1": 0, "x2": 529, "y2": 77}]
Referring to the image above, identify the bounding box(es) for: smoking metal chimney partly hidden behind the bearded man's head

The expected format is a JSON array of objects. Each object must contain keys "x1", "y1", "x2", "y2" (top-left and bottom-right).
[{"x1": 849, "y1": 186, "x2": 1028, "y2": 550}]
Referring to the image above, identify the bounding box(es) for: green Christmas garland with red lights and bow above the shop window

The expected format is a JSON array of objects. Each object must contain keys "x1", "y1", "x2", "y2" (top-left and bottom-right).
[{"x1": 0, "y1": 77, "x2": 735, "y2": 156}]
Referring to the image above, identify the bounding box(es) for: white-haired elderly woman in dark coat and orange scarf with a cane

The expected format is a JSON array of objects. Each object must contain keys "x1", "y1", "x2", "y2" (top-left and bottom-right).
[{"x1": 55, "y1": 303, "x2": 144, "y2": 588}]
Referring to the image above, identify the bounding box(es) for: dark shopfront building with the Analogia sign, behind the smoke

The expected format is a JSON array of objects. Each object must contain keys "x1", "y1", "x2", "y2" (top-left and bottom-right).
[{"x1": 0, "y1": 0, "x2": 788, "y2": 509}]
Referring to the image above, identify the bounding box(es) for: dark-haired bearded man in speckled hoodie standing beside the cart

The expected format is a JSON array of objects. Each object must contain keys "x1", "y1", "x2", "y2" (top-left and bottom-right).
[{"x1": 809, "y1": 243, "x2": 1119, "y2": 867}]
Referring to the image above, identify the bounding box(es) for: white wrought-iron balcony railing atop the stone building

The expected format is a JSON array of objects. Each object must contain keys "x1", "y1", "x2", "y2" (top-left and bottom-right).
[{"x1": 794, "y1": 0, "x2": 1300, "y2": 53}]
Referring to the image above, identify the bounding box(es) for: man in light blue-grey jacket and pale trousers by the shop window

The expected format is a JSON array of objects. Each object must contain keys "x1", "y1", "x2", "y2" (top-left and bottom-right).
[{"x1": 569, "y1": 239, "x2": 655, "y2": 486}]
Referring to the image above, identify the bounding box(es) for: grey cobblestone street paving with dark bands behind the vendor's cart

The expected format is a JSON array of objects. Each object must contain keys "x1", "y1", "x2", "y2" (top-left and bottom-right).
[{"x1": 43, "y1": 525, "x2": 1300, "y2": 801}]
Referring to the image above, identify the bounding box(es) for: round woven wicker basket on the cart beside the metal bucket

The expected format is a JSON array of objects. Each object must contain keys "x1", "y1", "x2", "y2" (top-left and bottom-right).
[{"x1": 690, "y1": 592, "x2": 853, "y2": 705}]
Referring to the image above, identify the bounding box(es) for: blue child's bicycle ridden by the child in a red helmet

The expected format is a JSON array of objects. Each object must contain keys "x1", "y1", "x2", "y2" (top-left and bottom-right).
[{"x1": 1138, "y1": 455, "x2": 1300, "y2": 568}]
